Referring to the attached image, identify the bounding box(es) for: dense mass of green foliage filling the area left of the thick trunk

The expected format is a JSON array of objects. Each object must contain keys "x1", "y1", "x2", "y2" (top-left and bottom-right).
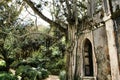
[{"x1": 0, "y1": 1, "x2": 65, "y2": 80}]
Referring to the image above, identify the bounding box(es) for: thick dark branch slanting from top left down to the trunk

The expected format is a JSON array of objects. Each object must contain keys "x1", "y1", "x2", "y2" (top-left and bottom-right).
[{"x1": 23, "y1": 0, "x2": 66, "y2": 32}]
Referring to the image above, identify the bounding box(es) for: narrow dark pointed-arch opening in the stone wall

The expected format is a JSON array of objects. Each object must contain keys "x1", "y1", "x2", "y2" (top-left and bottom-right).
[{"x1": 83, "y1": 39, "x2": 94, "y2": 76}]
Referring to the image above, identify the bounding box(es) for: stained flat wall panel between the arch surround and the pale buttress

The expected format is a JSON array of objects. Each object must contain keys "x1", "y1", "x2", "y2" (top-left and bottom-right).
[{"x1": 93, "y1": 27, "x2": 111, "y2": 80}]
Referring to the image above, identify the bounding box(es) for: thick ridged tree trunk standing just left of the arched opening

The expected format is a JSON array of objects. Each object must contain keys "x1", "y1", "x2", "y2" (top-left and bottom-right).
[{"x1": 66, "y1": 25, "x2": 78, "y2": 80}]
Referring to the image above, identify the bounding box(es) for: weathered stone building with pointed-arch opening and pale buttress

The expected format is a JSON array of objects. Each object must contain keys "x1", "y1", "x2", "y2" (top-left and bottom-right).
[{"x1": 69, "y1": 0, "x2": 120, "y2": 80}]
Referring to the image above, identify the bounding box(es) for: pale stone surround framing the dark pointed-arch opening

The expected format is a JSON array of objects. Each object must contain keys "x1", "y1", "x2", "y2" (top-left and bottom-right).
[{"x1": 77, "y1": 30, "x2": 97, "y2": 80}]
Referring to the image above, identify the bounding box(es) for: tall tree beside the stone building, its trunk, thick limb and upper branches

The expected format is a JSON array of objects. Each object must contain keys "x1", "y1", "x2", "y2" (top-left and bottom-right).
[{"x1": 23, "y1": 0, "x2": 102, "y2": 80}]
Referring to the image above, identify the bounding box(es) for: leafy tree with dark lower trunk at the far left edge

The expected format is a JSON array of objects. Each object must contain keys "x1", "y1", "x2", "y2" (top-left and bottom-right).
[{"x1": 0, "y1": 0, "x2": 22, "y2": 71}]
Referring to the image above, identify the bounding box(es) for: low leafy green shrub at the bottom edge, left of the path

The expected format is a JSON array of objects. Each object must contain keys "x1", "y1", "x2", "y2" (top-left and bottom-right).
[{"x1": 16, "y1": 65, "x2": 49, "y2": 80}]
